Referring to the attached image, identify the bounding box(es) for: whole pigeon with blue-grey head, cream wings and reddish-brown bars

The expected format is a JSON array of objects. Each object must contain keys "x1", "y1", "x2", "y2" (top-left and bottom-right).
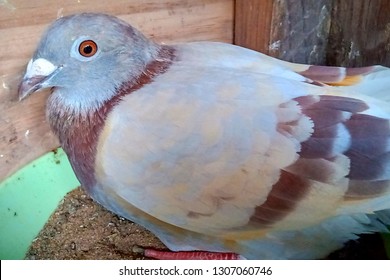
[{"x1": 18, "y1": 13, "x2": 390, "y2": 259}]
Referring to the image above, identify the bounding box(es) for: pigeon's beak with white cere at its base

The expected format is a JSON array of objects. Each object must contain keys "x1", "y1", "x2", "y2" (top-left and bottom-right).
[{"x1": 18, "y1": 58, "x2": 62, "y2": 101}]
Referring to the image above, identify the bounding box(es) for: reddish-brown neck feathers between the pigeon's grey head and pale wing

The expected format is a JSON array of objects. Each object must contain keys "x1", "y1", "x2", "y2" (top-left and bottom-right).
[{"x1": 47, "y1": 46, "x2": 175, "y2": 194}]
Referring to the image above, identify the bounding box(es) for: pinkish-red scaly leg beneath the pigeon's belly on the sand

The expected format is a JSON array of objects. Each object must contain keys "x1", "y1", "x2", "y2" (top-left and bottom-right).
[{"x1": 133, "y1": 247, "x2": 244, "y2": 260}]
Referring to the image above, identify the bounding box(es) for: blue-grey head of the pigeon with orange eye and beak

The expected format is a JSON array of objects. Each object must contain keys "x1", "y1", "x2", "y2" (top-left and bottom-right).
[{"x1": 19, "y1": 13, "x2": 160, "y2": 113}]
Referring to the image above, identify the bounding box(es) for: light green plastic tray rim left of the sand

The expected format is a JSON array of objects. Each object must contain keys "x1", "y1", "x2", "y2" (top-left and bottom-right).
[{"x1": 0, "y1": 149, "x2": 80, "y2": 260}]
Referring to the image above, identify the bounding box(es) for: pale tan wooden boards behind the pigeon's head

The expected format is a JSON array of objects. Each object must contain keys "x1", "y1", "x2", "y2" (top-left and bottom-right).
[{"x1": 0, "y1": 0, "x2": 234, "y2": 181}]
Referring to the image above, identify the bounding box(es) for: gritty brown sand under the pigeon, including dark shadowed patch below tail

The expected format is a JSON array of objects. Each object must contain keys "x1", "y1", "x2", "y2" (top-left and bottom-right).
[{"x1": 26, "y1": 188, "x2": 386, "y2": 260}]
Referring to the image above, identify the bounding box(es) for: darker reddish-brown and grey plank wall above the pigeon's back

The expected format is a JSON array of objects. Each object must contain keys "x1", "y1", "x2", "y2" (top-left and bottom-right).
[{"x1": 235, "y1": 0, "x2": 390, "y2": 67}]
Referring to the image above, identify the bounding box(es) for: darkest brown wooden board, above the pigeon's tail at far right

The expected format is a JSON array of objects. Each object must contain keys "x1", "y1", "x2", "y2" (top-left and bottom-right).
[{"x1": 326, "y1": 0, "x2": 390, "y2": 66}]
